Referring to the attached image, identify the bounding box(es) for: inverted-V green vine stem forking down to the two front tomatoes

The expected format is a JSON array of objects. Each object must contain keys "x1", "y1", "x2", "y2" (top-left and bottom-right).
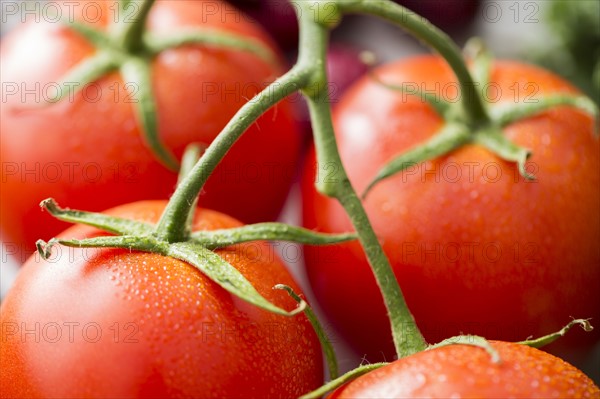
[{"x1": 155, "y1": 2, "x2": 426, "y2": 357}]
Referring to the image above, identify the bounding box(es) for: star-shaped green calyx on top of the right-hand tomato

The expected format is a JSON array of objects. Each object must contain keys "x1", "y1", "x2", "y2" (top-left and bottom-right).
[{"x1": 362, "y1": 38, "x2": 599, "y2": 199}]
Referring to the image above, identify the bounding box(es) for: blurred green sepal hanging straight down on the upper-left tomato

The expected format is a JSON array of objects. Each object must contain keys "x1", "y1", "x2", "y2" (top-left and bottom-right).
[{"x1": 121, "y1": 57, "x2": 179, "y2": 170}]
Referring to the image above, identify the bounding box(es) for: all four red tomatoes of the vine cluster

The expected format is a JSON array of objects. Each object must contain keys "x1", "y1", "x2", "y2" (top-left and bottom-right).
[{"x1": 0, "y1": 0, "x2": 600, "y2": 398}]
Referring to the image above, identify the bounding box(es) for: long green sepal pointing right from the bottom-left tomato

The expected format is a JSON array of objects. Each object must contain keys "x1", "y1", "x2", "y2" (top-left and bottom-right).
[{"x1": 192, "y1": 223, "x2": 358, "y2": 249}]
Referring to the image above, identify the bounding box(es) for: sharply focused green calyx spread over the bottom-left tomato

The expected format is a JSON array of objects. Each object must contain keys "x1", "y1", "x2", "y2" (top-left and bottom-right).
[{"x1": 36, "y1": 199, "x2": 356, "y2": 316}]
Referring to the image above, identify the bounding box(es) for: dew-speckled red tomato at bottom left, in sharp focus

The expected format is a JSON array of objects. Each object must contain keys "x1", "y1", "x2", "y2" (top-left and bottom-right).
[{"x1": 0, "y1": 201, "x2": 323, "y2": 398}]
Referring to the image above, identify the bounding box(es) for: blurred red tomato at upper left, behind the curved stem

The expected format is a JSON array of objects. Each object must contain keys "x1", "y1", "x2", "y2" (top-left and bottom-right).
[{"x1": 0, "y1": 0, "x2": 300, "y2": 261}]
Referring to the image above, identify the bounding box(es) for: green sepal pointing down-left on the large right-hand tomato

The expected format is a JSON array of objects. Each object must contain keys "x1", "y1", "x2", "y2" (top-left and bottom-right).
[{"x1": 362, "y1": 123, "x2": 471, "y2": 199}]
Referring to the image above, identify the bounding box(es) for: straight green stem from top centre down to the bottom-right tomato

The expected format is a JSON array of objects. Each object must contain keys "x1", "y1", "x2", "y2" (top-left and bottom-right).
[{"x1": 298, "y1": 3, "x2": 427, "y2": 357}]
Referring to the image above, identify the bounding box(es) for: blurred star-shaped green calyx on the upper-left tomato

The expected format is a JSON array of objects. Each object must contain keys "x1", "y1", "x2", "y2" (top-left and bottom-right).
[{"x1": 39, "y1": 0, "x2": 277, "y2": 170}]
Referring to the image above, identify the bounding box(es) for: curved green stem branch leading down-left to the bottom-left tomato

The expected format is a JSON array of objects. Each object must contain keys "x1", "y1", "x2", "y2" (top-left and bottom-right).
[{"x1": 155, "y1": 67, "x2": 308, "y2": 242}]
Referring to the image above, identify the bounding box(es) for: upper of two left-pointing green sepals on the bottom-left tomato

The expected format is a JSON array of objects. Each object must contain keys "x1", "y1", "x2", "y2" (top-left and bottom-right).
[{"x1": 40, "y1": 198, "x2": 154, "y2": 236}]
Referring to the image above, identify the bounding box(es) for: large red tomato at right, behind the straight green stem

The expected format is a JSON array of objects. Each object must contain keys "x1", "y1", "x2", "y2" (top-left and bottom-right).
[{"x1": 303, "y1": 56, "x2": 600, "y2": 360}]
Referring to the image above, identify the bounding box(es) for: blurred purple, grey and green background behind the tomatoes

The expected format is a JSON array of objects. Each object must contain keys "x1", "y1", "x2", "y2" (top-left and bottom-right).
[{"x1": 0, "y1": 0, "x2": 600, "y2": 383}]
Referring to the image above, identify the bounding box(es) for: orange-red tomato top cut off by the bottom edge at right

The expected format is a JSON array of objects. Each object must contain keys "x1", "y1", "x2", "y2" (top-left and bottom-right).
[{"x1": 330, "y1": 341, "x2": 600, "y2": 399}]
